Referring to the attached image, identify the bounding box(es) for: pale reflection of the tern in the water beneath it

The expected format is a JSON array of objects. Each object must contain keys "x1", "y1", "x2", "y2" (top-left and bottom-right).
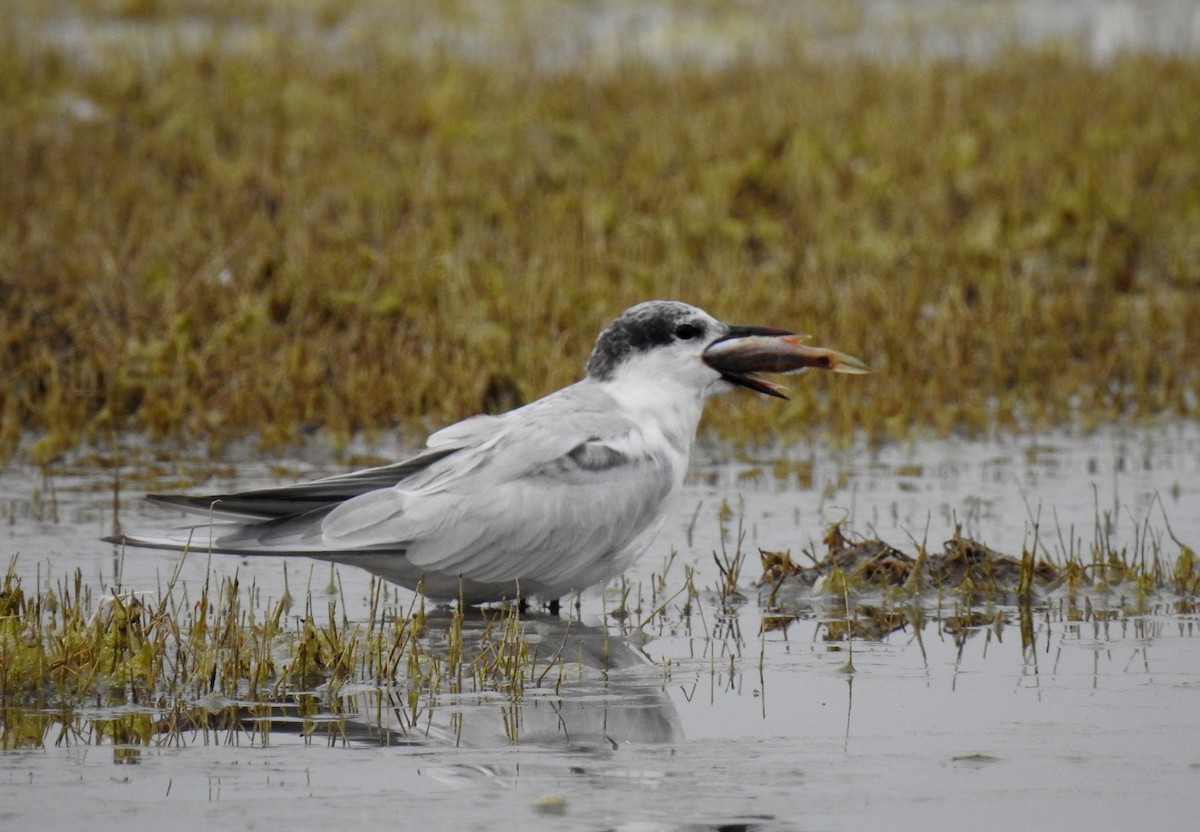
[{"x1": 240, "y1": 610, "x2": 683, "y2": 748}]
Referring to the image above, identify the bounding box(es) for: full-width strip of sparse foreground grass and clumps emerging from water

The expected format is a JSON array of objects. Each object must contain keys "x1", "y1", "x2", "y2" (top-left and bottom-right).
[{"x1": 0, "y1": 506, "x2": 1200, "y2": 748}]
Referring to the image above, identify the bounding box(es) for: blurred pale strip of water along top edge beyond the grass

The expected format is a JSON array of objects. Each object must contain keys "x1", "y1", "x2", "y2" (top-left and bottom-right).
[{"x1": 13, "y1": 0, "x2": 1200, "y2": 72}]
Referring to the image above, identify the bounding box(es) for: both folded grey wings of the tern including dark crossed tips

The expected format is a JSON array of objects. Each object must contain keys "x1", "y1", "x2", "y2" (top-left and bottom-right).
[{"x1": 129, "y1": 388, "x2": 682, "y2": 590}]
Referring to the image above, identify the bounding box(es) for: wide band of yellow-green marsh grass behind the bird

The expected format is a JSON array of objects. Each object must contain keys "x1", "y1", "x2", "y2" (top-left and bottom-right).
[{"x1": 0, "y1": 4, "x2": 1200, "y2": 460}]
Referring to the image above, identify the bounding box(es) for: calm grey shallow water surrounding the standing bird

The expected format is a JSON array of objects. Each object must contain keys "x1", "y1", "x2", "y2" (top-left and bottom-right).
[{"x1": 0, "y1": 425, "x2": 1200, "y2": 830}]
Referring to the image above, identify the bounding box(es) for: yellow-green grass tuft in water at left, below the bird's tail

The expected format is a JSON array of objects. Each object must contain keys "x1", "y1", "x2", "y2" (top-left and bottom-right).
[{"x1": 0, "y1": 558, "x2": 571, "y2": 747}]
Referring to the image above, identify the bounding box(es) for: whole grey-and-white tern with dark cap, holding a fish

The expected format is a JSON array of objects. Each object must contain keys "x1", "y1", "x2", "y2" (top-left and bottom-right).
[{"x1": 106, "y1": 300, "x2": 868, "y2": 607}]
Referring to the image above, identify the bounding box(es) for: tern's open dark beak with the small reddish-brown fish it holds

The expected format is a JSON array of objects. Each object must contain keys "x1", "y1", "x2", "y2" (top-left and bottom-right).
[{"x1": 702, "y1": 327, "x2": 870, "y2": 399}]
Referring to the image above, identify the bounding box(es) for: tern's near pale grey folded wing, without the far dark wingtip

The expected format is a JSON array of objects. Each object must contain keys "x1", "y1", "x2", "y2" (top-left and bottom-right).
[{"x1": 220, "y1": 387, "x2": 686, "y2": 583}]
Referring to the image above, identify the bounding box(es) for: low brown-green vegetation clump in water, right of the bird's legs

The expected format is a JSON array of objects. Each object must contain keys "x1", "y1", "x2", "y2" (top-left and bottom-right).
[{"x1": 757, "y1": 513, "x2": 1200, "y2": 641}]
